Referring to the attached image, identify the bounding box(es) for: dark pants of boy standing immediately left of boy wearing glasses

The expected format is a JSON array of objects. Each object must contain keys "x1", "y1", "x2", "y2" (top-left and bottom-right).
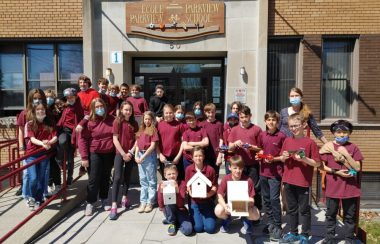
[{"x1": 260, "y1": 176, "x2": 281, "y2": 228}]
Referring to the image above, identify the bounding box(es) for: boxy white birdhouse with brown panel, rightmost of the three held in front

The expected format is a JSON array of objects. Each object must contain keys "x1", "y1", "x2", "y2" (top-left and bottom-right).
[{"x1": 227, "y1": 181, "x2": 249, "y2": 216}]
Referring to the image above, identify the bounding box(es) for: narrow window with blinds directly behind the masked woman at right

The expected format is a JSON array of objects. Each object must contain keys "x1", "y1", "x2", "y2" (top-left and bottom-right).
[{"x1": 267, "y1": 39, "x2": 299, "y2": 111}]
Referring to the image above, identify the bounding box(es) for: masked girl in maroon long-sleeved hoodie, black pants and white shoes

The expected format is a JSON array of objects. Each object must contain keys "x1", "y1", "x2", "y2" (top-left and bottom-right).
[{"x1": 78, "y1": 98, "x2": 115, "y2": 216}]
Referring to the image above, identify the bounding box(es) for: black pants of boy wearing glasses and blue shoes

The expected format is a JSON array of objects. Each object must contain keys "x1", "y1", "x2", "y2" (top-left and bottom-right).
[{"x1": 284, "y1": 183, "x2": 311, "y2": 236}]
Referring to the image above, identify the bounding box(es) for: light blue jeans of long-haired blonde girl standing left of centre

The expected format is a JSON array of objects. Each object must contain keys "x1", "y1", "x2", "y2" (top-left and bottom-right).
[{"x1": 138, "y1": 151, "x2": 157, "y2": 204}]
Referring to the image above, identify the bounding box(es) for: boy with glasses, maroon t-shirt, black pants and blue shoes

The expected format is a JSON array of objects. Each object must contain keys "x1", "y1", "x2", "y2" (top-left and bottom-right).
[{"x1": 279, "y1": 113, "x2": 320, "y2": 244}]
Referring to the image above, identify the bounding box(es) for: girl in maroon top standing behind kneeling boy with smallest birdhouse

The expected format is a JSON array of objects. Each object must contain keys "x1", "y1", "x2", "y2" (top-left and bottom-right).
[{"x1": 157, "y1": 104, "x2": 184, "y2": 179}]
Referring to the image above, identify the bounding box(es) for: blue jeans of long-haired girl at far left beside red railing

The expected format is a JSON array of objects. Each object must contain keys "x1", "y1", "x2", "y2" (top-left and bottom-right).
[{"x1": 26, "y1": 155, "x2": 49, "y2": 202}]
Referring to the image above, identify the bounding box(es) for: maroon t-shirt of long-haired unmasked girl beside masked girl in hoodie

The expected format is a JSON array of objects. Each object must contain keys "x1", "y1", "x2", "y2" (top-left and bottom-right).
[{"x1": 112, "y1": 119, "x2": 138, "y2": 154}]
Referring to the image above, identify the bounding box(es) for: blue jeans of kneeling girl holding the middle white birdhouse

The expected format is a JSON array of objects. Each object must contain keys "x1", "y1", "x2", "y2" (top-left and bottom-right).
[{"x1": 190, "y1": 201, "x2": 216, "y2": 234}]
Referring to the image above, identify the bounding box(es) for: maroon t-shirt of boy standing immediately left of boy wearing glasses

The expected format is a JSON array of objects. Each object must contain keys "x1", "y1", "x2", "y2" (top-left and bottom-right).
[{"x1": 258, "y1": 130, "x2": 286, "y2": 178}]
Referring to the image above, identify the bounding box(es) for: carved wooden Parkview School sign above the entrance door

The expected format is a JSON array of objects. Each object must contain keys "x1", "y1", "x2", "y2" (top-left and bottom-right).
[{"x1": 126, "y1": 0, "x2": 225, "y2": 40}]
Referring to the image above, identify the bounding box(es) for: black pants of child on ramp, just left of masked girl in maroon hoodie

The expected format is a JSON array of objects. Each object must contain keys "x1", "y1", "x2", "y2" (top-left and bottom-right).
[{"x1": 56, "y1": 128, "x2": 75, "y2": 179}]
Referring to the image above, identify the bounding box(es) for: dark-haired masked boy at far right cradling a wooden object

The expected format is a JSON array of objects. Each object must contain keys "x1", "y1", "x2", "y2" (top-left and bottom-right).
[{"x1": 320, "y1": 120, "x2": 364, "y2": 244}]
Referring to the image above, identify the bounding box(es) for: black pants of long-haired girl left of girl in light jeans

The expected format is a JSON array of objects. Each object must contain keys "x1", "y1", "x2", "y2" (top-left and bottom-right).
[{"x1": 112, "y1": 154, "x2": 135, "y2": 202}]
